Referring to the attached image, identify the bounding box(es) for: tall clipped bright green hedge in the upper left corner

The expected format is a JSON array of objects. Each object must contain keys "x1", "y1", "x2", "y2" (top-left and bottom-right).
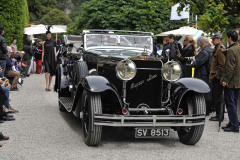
[{"x1": 0, "y1": 0, "x2": 29, "y2": 50}]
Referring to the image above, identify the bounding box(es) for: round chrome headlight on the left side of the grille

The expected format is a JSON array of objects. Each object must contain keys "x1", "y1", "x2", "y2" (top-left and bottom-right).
[{"x1": 116, "y1": 59, "x2": 137, "y2": 81}]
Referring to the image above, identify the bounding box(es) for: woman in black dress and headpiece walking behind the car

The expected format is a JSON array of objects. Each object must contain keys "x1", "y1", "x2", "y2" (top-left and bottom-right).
[{"x1": 42, "y1": 26, "x2": 57, "y2": 91}]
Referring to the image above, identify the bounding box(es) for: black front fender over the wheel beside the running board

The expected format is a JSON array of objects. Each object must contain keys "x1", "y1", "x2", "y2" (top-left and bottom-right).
[{"x1": 73, "y1": 75, "x2": 123, "y2": 113}]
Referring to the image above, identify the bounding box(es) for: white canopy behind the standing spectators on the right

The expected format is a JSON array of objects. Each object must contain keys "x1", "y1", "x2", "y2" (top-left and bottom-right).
[{"x1": 156, "y1": 26, "x2": 205, "y2": 37}]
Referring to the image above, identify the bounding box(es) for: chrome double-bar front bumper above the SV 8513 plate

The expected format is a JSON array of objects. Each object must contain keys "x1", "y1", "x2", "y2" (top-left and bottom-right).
[{"x1": 94, "y1": 114, "x2": 206, "y2": 127}]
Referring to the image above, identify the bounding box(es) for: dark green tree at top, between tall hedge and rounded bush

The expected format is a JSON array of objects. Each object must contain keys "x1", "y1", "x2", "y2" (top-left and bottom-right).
[{"x1": 27, "y1": 0, "x2": 57, "y2": 21}]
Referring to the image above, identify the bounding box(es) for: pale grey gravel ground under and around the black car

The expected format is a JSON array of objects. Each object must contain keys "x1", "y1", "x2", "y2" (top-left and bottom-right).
[{"x1": 0, "y1": 75, "x2": 240, "y2": 160}]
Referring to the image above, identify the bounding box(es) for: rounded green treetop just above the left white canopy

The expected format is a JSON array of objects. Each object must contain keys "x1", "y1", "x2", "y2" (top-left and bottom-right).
[{"x1": 40, "y1": 9, "x2": 72, "y2": 25}]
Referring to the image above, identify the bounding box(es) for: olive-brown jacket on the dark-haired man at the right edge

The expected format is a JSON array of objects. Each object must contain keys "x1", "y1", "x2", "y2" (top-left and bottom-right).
[{"x1": 221, "y1": 43, "x2": 240, "y2": 88}]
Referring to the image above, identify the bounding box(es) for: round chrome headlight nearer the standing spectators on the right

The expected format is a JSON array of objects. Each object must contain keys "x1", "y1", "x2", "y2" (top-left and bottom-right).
[{"x1": 162, "y1": 61, "x2": 181, "y2": 81}]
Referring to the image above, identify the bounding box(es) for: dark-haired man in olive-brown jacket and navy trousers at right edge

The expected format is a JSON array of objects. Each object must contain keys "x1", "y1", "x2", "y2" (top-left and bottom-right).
[{"x1": 221, "y1": 30, "x2": 240, "y2": 133}]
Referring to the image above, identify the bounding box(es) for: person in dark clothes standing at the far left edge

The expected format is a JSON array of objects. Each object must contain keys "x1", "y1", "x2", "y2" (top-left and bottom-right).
[{"x1": 0, "y1": 26, "x2": 7, "y2": 77}]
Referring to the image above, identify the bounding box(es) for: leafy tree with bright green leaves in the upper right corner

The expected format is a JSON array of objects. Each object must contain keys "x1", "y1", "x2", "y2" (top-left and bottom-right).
[{"x1": 168, "y1": 0, "x2": 240, "y2": 33}]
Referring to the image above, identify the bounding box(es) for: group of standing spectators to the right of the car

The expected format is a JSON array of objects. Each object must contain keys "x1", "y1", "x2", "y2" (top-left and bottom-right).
[{"x1": 160, "y1": 29, "x2": 240, "y2": 132}]
